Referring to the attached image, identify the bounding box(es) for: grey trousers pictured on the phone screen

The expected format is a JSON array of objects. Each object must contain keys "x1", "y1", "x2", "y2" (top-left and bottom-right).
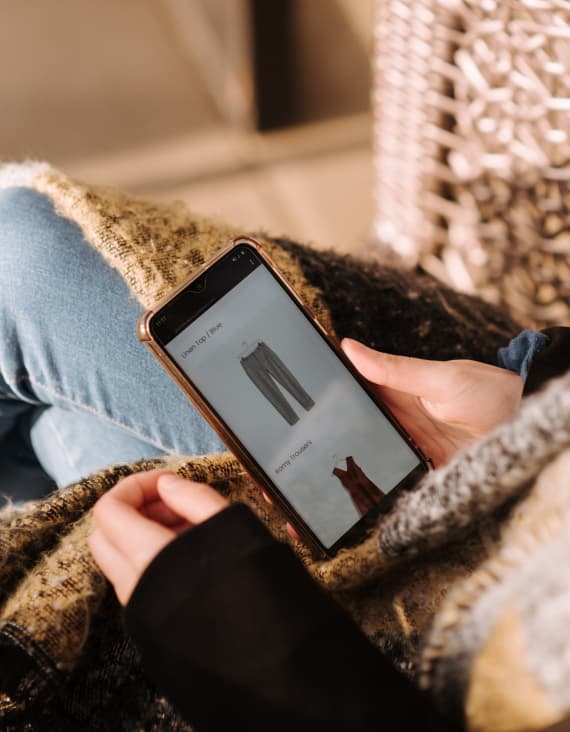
[{"x1": 240, "y1": 341, "x2": 315, "y2": 425}]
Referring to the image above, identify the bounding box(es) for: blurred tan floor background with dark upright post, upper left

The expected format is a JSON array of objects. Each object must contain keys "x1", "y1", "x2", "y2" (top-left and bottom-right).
[{"x1": 0, "y1": 0, "x2": 373, "y2": 251}]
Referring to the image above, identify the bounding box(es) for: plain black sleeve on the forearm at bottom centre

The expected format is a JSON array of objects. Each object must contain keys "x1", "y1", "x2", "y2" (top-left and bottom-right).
[{"x1": 126, "y1": 504, "x2": 450, "y2": 732}]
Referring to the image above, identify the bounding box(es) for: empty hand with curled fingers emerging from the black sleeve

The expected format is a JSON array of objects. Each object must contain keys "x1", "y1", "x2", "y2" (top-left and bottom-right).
[{"x1": 89, "y1": 470, "x2": 229, "y2": 605}]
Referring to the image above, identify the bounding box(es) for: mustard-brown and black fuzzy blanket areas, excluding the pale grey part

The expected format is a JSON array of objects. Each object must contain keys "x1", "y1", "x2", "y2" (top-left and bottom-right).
[{"x1": 0, "y1": 165, "x2": 519, "y2": 732}]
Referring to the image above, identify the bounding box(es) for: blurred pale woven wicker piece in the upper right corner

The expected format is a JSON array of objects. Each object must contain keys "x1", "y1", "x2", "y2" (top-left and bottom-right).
[{"x1": 373, "y1": 0, "x2": 570, "y2": 325}]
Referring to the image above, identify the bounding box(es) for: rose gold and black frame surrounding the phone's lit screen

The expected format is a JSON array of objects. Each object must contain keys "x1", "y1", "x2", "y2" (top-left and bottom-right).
[{"x1": 137, "y1": 236, "x2": 430, "y2": 557}]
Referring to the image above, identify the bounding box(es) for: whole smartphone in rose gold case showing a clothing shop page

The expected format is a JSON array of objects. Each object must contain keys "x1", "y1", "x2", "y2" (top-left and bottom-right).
[{"x1": 138, "y1": 237, "x2": 429, "y2": 556}]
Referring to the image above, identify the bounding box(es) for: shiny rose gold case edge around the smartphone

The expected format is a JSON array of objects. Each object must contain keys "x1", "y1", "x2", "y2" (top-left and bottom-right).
[{"x1": 137, "y1": 236, "x2": 425, "y2": 556}]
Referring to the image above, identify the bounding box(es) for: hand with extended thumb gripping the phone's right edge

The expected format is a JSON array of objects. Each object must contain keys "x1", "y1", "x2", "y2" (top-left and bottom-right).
[{"x1": 342, "y1": 338, "x2": 523, "y2": 467}]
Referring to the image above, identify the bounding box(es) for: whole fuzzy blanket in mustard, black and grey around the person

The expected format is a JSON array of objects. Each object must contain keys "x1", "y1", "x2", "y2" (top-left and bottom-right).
[{"x1": 0, "y1": 164, "x2": 570, "y2": 732}]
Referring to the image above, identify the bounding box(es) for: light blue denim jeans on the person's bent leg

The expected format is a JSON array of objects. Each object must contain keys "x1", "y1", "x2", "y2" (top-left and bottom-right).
[{"x1": 0, "y1": 188, "x2": 225, "y2": 498}]
